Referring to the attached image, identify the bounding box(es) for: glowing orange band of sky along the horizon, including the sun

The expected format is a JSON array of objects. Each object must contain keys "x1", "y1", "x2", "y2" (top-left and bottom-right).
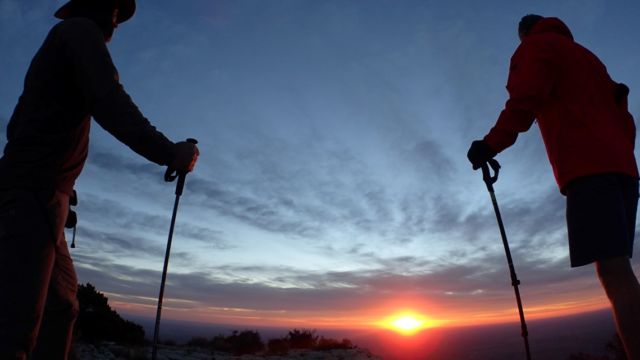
[{"x1": 106, "y1": 293, "x2": 608, "y2": 337}]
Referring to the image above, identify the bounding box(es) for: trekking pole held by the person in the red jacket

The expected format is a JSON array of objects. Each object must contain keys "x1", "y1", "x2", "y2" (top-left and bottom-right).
[{"x1": 482, "y1": 159, "x2": 531, "y2": 360}]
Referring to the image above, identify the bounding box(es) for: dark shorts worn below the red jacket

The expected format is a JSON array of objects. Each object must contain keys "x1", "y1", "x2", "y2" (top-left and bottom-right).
[{"x1": 566, "y1": 173, "x2": 638, "y2": 267}]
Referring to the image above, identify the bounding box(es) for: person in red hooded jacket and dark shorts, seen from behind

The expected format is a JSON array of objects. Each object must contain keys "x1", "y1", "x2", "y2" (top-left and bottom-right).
[{"x1": 467, "y1": 15, "x2": 640, "y2": 360}]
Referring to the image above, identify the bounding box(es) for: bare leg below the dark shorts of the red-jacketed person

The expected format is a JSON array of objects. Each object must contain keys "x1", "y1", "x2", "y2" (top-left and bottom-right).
[{"x1": 596, "y1": 257, "x2": 640, "y2": 360}]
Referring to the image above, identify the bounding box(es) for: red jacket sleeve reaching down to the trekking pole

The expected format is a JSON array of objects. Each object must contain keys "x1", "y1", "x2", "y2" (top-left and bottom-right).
[{"x1": 484, "y1": 38, "x2": 555, "y2": 152}]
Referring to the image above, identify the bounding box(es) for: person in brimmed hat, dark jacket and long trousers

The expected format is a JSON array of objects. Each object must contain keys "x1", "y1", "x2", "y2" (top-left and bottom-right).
[{"x1": 0, "y1": 0, "x2": 198, "y2": 359}]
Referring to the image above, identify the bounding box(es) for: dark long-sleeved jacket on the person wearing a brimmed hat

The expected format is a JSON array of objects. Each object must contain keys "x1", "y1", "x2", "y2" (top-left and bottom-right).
[{"x1": 0, "y1": 18, "x2": 174, "y2": 194}]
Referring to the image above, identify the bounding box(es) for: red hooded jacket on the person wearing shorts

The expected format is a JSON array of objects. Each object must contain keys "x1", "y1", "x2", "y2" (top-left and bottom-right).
[{"x1": 484, "y1": 18, "x2": 638, "y2": 193}]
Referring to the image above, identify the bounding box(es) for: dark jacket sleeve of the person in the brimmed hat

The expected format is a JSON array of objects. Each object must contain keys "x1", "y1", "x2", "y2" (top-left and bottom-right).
[{"x1": 62, "y1": 19, "x2": 175, "y2": 165}]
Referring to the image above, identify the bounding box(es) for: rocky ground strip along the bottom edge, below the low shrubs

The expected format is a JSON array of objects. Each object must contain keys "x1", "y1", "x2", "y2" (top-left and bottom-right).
[{"x1": 75, "y1": 343, "x2": 382, "y2": 360}]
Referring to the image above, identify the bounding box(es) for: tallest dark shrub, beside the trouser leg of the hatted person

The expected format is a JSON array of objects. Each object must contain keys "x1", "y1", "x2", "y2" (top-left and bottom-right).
[{"x1": 74, "y1": 283, "x2": 144, "y2": 345}]
